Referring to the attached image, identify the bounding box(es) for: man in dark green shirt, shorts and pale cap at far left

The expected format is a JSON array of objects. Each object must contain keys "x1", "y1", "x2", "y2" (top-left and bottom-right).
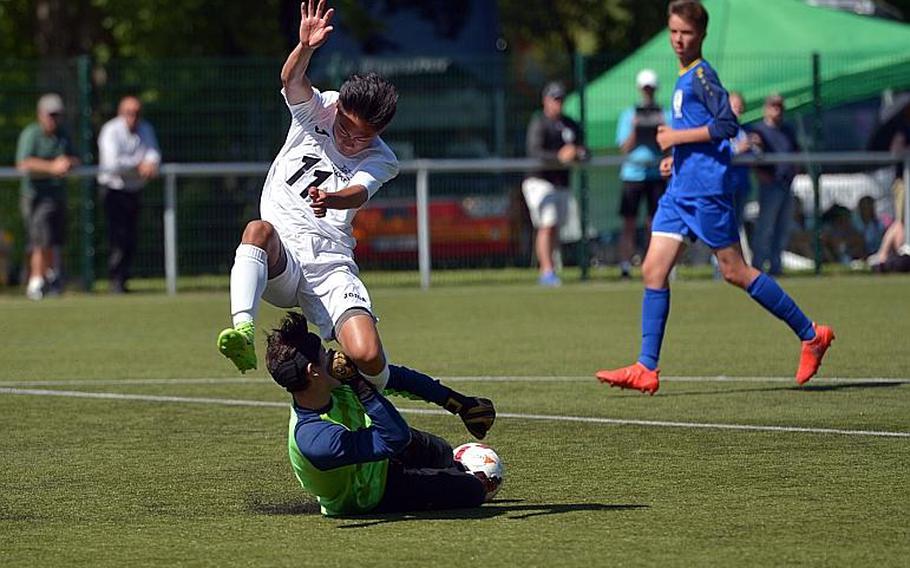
[{"x1": 16, "y1": 93, "x2": 79, "y2": 300}]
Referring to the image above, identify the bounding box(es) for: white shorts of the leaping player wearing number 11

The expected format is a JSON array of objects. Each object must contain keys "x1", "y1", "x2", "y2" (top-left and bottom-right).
[{"x1": 262, "y1": 235, "x2": 372, "y2": 340}]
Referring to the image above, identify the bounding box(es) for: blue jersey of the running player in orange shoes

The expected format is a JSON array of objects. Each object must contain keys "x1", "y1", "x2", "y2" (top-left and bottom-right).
[{"x1": 667, "y1": 59, "x2": 739, "y2": 197}]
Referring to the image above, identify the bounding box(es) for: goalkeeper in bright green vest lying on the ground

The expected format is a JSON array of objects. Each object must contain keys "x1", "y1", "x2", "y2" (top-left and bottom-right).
[{"x1": 266, "y1": 312, "x2": 496, "y2": 516}]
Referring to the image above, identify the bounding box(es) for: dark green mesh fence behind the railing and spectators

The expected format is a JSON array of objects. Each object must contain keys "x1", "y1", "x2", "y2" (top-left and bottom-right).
[{"x1": 0, "y1": 53, "x2": 910, "y2": 285}]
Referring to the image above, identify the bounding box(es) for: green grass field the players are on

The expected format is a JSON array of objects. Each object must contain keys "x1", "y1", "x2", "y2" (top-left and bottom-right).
[{"x1": 0, "y1": 277, "x2": 910, "y2": 568}]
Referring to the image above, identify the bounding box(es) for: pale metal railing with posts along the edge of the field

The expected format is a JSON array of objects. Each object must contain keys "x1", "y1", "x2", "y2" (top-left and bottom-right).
[{"x1": 0, "y1": 152, "x2": 910, "y2": 295}]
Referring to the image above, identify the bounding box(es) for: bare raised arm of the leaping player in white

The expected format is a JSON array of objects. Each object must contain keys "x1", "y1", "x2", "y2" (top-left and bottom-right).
[{"x1": 281, "y1": 0, "x2": 335, "y2": 104}]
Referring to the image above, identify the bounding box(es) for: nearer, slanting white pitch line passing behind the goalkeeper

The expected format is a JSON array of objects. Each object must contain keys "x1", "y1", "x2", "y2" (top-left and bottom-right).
[{"x1": 0, "y1": 388, "x2": 910, "y2": 438}]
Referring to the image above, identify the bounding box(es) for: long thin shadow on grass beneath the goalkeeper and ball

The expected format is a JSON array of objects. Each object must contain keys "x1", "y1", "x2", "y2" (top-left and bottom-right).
[{"x1": 338, "y1": 499, "x2": 650, "y2": 529}]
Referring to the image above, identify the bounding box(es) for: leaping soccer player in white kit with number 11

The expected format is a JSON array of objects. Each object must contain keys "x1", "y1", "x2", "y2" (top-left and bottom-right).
[{"x1": 218, "y1": 0, "x2": 398, "y2": 388}]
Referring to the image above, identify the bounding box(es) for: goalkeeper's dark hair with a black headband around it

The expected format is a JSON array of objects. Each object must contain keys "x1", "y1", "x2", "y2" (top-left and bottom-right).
[{"x1": 265, "y1": 312, "x2": 322, "y2": 393}]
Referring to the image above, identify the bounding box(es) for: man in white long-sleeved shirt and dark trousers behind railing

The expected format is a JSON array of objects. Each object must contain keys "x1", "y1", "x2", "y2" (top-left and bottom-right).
[{"x1": 98, "y1": 95, "x2": 161, "y2": 293}]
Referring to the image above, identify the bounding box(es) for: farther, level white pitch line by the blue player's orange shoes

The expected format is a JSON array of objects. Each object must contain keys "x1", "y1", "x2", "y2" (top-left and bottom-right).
[{"x1": 0, "y1": 374, "x2": 910, "y2": 387}]
